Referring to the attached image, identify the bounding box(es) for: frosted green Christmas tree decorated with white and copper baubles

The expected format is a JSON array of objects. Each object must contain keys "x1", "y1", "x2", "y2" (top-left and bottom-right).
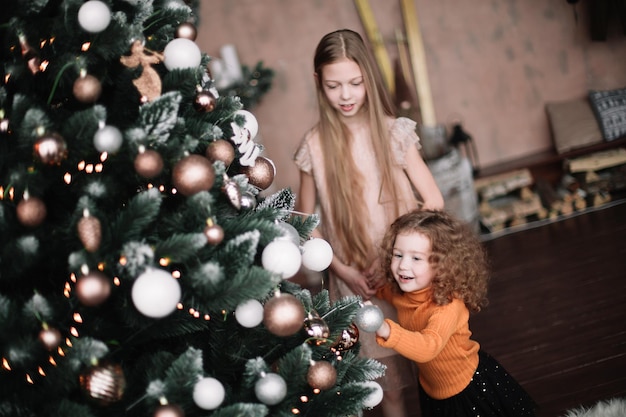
[{"x1": 0, "y1": 0, "x2": 384, "y2": 417}]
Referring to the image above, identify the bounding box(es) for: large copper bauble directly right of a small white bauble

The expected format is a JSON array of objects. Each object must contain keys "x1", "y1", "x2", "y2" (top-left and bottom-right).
[{"x1": 263, "y1": 293, "x2": 305, "y2": 337}]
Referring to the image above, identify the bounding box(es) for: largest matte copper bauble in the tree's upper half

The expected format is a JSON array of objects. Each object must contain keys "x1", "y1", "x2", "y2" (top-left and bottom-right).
[{"x1": 172, "y1": 155, "x2": 215, "y2": 196}]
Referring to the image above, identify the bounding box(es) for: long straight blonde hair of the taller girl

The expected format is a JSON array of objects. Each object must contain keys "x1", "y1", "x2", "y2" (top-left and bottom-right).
[{"x1": 313, "y1": 29, "x2": 399, "y2": 269}]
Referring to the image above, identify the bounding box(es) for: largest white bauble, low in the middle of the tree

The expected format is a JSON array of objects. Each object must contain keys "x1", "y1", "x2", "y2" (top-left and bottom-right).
[{"x1": 131, "y1": 268, "x2": 181, "y2": 318}]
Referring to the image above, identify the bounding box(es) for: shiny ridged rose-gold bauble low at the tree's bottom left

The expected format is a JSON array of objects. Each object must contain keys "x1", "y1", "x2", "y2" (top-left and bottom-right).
[{"x1": 79, "y1": 364, "x2": 126, "y2": 406}]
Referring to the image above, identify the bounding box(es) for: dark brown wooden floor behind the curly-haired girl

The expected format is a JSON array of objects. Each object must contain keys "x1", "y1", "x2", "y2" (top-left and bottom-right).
[{"x1": 352, "y1": 198, "x2": 626, "y2": 417}]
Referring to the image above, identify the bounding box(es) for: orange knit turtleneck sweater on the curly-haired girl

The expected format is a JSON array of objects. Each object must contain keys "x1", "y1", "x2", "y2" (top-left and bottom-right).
[{"x1": 376, "y1": 286, "x2": 480, "y2": 399}]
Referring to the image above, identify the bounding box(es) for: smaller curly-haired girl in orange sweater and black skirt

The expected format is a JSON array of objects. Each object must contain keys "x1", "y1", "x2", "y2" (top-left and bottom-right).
[{"x1": 376, "y1": 210, "x2": 536, "y2": 417}]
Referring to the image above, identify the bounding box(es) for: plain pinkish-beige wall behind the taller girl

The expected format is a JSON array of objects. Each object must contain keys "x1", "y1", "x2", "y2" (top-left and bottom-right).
[{"x1": 197, "y1": 0, "x2": 626, "y2": 191}]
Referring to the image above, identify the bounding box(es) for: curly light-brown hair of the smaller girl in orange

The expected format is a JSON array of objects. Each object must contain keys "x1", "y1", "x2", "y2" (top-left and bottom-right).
[{"x1": 381, "y1": 210, "x2": 489, "y2": 312}]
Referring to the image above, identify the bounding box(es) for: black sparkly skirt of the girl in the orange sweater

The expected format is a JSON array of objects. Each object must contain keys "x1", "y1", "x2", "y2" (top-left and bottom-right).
[{"x1": 420, "y1": 351, "x2": 537, "y2": 417}]
